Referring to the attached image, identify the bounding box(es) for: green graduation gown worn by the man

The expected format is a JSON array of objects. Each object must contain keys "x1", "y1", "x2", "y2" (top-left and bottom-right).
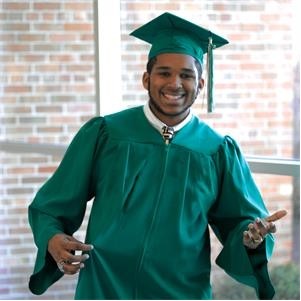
[{"x1": 29, "y1": 107, "x2": 274, "y2": 300}]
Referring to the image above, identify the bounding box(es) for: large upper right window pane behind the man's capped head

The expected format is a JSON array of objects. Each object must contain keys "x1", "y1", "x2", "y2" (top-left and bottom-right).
[{"x1": 121, "y1": 0, "x2": 300, "y2": 158}]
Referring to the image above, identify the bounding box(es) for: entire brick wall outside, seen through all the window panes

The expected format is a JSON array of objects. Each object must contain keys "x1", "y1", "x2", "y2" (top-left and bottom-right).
[{"x1": 0, "y1": 0, "x2": 295, "y2": 299}]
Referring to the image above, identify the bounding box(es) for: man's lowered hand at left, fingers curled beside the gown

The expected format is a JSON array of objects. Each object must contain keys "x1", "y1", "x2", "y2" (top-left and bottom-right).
[{"x1": 48, "y1": 234, "x2": 93, "y2": 275}]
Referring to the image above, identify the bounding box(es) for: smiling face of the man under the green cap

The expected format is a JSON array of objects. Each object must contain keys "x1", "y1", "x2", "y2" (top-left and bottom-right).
[{"x1": 143, "y1": 53, "x2": 204, "y2": 126}]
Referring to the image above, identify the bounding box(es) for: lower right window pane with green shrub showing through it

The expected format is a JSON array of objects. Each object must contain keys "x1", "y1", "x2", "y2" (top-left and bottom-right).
[{"x1": 211, "y1": 174, "x2": 300, "y2": 300}]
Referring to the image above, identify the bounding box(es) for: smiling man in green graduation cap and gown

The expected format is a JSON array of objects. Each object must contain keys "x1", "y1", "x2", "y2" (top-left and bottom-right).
[{"x1": 29, "y1": 13, "x2": 285, "y2": 299}]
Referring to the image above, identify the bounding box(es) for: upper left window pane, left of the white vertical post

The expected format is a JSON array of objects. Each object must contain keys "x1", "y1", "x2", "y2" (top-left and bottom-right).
[{"x1": 0, "y1": 1, "x2": 95, "y2": 143}]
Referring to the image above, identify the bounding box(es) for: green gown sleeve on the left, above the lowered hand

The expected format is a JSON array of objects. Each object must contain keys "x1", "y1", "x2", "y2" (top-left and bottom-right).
[{"x1": 28, "y1": 117, "x2": 104, "y2": 295}]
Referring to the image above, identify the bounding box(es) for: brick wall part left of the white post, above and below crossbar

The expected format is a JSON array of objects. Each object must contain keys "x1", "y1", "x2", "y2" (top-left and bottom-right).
[{"x1": 0, "y1": 0, "x2": 96, "y2": 299}]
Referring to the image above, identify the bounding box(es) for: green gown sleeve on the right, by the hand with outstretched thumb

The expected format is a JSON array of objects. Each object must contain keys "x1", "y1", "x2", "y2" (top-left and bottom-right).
[{"x1": 209, "y1": 136, "x2": 275, "y2": 299}]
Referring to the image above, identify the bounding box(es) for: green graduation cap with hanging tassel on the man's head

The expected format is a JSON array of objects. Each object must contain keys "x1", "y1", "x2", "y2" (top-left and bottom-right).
[{"x1": 130, "y1": 13, "x2": 229, "y2": 112}]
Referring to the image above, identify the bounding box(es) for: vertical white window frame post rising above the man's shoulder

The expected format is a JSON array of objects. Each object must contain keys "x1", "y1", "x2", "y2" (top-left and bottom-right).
[{"x1": 93, "y1": 0, "x2": 122, "y2": 115}]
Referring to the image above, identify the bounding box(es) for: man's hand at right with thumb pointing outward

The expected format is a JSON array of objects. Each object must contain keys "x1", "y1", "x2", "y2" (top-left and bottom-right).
[{"x1": 243, "y1": 210, "x2": 287, "y2": 249}]
